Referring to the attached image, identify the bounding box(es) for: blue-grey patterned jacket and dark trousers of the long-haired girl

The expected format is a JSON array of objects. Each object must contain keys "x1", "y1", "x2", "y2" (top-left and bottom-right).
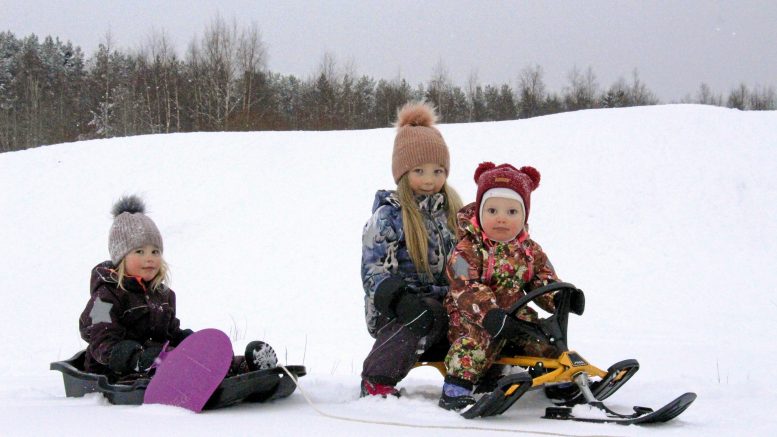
[{"x1": 361, "y1": 190, "x2": 456, "y2": 385}]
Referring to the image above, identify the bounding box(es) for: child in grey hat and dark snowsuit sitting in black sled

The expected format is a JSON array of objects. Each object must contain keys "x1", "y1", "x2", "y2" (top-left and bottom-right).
[{"x1": 78, "y1": 196, "x2": 277, "y2": 380}]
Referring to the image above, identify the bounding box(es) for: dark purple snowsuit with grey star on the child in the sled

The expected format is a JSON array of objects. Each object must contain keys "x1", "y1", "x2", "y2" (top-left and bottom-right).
[{"x1": 78, "y1": 261, "x2": 192, "y2": 374}]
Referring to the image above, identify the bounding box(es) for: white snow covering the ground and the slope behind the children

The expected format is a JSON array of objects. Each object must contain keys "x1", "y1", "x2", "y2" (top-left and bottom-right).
[{"x1": 0, "y1": 105, "x2": 777, "y2": 436}]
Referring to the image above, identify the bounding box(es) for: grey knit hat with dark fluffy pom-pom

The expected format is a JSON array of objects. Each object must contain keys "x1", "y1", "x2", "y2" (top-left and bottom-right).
[{"x1": 108, "y1": 195, "x2": 164, "y2": 266}]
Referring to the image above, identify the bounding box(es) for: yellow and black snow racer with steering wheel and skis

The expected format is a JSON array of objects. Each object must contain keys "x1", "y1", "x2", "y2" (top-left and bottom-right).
[{"x1": 417, "y1": 282, "x2": 696, "y2": 425}]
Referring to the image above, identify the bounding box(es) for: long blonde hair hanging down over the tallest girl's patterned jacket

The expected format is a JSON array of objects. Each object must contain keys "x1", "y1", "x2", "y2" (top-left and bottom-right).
[{"x1": 397, "y1": 173, "x2": 463, "y2": 277}]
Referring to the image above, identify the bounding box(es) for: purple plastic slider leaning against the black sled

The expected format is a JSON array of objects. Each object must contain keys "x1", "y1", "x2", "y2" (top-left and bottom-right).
[{"x1": 143, "y1": 329, "x2": 232, "y2": 413}]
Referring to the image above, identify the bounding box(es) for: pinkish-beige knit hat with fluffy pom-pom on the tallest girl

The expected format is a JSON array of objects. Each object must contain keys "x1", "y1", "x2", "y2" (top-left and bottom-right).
[{"x1": 391, "y1": 102, "x2": 450, "y2": 183}]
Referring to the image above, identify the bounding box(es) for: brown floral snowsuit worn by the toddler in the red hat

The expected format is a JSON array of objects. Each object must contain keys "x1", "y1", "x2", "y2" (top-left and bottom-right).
[{"x1": 445, "y1": 203, "x2": 559, "y2": 384}]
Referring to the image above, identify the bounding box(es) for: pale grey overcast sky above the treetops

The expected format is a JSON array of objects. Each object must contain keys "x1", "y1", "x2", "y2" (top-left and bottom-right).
[{"x1": 0, "y1": 0, "x2": 777, "y2": 102}]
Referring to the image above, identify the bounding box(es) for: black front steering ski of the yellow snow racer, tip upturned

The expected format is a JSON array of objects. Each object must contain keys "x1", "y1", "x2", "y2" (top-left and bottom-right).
[{"x1": 542, "y1": 393, "x2": 696, "y2": 425}]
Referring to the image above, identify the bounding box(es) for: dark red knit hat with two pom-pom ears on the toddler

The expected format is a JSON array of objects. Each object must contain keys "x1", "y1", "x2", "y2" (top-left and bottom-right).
[{"x1": 475, "y1": 162, "x2": 540, "y2": 222}]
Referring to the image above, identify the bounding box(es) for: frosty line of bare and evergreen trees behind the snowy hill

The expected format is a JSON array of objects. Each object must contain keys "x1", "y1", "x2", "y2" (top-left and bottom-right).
[{"x1": 0, "y1": 17, "x2": 777, "y2": 152}]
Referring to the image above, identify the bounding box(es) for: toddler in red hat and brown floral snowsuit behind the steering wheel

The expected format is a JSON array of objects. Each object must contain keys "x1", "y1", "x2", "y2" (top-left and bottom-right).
[{"x1": 440, "y1": 162, "x2": 559, "y2": 410}]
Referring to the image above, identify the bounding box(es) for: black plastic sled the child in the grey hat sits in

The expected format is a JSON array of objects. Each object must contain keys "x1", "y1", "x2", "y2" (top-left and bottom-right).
[{"x1": 49, "y1": 351, "x2": 307, "y2": 410}]
